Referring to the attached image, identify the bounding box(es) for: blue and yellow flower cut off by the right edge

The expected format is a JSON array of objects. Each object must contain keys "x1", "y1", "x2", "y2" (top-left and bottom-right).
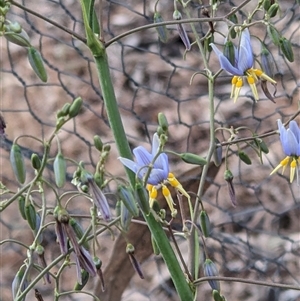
[{"x1": 271, "y1": 120, "x2": 300, "y2": 183}]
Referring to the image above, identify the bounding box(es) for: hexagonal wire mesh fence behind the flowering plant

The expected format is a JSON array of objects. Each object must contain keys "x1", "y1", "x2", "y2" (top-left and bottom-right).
[{"x1": 0, "y1": 0, "x2": 300, "y2": 301}]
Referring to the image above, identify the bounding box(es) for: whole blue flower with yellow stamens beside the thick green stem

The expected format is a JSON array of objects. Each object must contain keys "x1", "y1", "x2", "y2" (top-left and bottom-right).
[{"x1": 119, "y1": 133, "x2": 190, "y2": 217}]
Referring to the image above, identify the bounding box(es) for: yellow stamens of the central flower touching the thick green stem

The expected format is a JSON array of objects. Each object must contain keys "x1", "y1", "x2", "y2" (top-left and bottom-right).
[{"x1": 147, "y1": 173, "x2": 190, "y2": 217}]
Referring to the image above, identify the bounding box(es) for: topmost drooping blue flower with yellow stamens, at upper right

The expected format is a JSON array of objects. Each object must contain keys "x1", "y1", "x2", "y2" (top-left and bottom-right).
[{"x1": 210, "y1": 28, "x2": 276, "y2": 102}]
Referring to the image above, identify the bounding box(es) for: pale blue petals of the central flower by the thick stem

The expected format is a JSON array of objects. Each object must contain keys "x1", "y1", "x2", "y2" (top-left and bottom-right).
[{"x1": 119, "y1": 133, "x2": 169, "y2": 185}]
